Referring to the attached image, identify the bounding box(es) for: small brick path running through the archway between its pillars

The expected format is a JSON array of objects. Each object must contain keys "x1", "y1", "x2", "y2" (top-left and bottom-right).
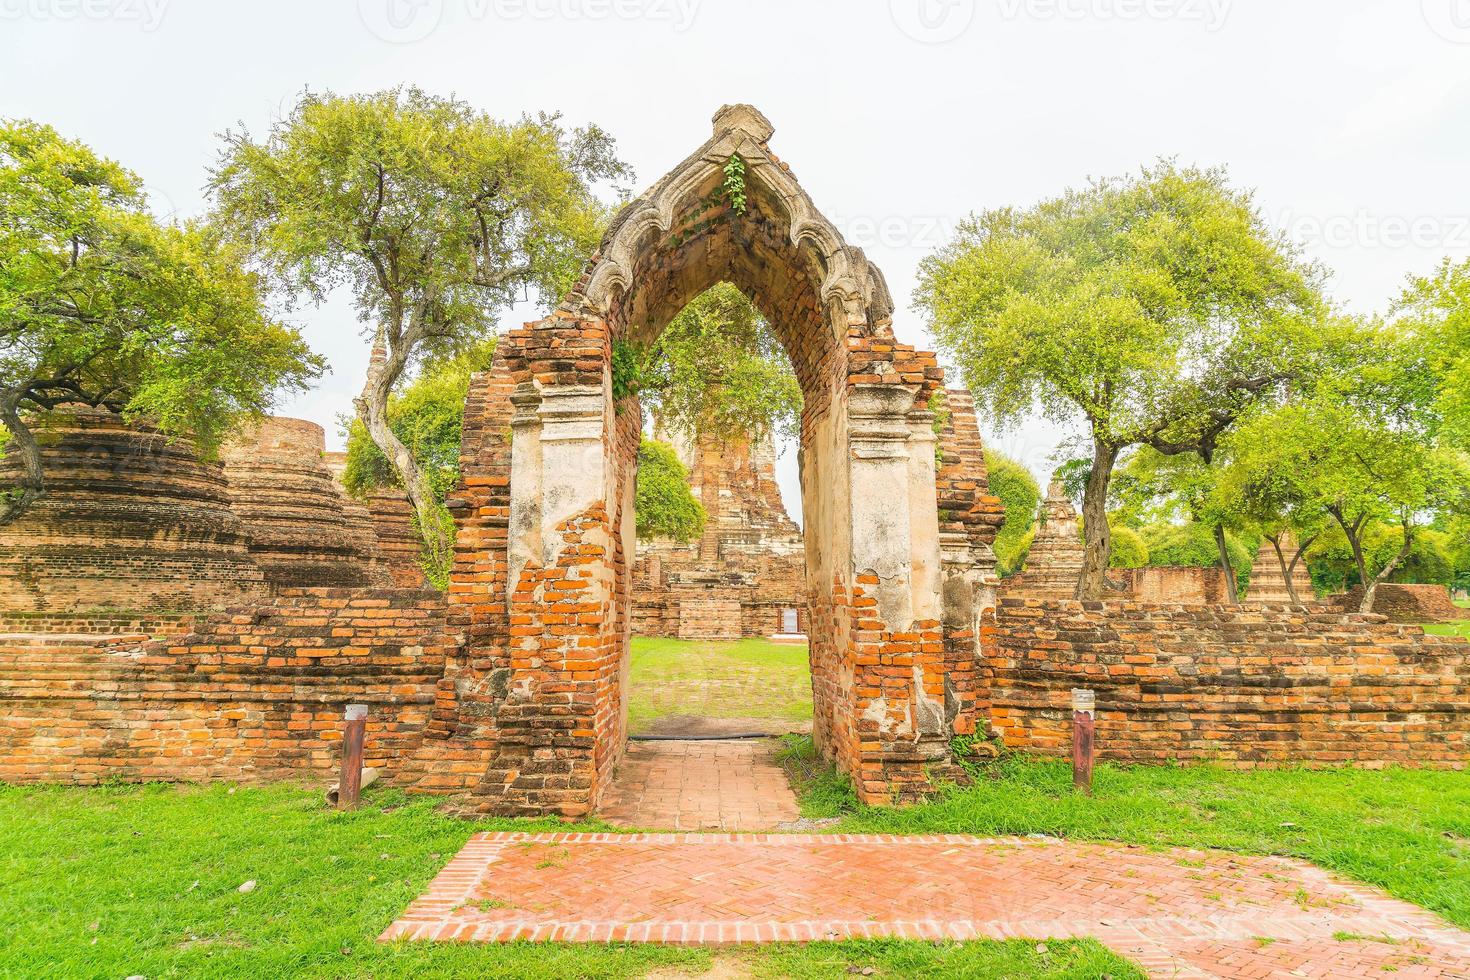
[{"x1": 597, "y1": 739, "x2": 801, "y2": 830}]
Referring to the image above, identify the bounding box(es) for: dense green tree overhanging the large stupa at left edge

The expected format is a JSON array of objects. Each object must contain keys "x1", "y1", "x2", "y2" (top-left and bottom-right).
[{"x1": 0, "y1": 120, "x2": 325, "y2": 525}]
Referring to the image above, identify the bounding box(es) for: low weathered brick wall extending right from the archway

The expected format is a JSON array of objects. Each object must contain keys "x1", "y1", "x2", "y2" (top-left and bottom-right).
[{"x1": 982, "y1": 598, "x2": 1470, "y2": 768}]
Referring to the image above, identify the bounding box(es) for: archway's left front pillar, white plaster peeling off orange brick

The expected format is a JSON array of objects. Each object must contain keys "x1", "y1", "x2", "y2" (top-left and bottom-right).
[{"x1": 492, "y1": 382, "x2": 623, "y2": 815}]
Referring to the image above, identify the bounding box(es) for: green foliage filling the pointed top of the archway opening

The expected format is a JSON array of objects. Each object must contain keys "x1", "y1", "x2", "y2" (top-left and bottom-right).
[{"x1": 625, "y1": 282, "x2": 801, "y2": 439}]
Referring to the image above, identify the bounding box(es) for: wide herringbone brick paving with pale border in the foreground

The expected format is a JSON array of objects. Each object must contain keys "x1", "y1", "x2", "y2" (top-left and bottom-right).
[{"x1": 382, "y1": 833, "x2": 1470, "y2": 980}]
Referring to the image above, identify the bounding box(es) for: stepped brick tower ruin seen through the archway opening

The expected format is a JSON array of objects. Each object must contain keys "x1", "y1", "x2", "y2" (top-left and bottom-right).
[{"x1": 632, "y1": 435, "x2": 806, "y2": 639}]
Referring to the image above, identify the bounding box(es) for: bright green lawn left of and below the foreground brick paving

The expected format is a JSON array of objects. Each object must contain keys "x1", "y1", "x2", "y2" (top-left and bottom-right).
[{"x1": 0, "y1": 786, "x2": 1142, "y2": 980}]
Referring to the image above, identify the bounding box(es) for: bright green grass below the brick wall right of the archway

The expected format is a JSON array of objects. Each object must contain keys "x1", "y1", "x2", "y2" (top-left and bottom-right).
[{"x1": 782, "y1": 745, "x2": 1470, "y2": 927}]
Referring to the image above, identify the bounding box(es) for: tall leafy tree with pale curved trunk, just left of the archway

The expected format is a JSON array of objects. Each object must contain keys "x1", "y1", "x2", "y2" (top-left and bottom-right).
[{"x1": 210, "y1": 88, "x2": 626, "y2": 578}]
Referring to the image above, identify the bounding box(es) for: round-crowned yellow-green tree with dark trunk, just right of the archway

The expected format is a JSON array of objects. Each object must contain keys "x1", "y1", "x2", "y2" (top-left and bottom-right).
[{"x1": 916, "y1": 162, "x2": 1323, "y2": 598}]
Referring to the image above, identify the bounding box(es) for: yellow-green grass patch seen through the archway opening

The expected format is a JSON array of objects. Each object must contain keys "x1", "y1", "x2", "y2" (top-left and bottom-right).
[{"x1": 628, "y1": 636, "x2": 811, "y2": 732}]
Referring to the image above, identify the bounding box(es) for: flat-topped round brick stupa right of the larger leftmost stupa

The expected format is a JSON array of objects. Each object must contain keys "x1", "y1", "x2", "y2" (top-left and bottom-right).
[{"x1": 223, "y1": 419, "x2": 388, "y2": 589}]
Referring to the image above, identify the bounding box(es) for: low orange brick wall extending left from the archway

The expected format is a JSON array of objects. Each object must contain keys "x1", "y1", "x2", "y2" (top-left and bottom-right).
[{"x1": 0, "y1": 589, "x2": 451, "y2": 783}]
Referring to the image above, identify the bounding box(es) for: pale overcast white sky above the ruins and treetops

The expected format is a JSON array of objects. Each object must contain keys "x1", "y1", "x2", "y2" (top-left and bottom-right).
[{"x1": 0, "y1": 0, "x2": 1470, "y2": 520}]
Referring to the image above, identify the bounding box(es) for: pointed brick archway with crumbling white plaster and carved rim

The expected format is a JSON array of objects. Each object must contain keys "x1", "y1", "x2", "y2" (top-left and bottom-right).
[{"x1": 431, "y1": 106, "x2": 998, "y2": 814}]
